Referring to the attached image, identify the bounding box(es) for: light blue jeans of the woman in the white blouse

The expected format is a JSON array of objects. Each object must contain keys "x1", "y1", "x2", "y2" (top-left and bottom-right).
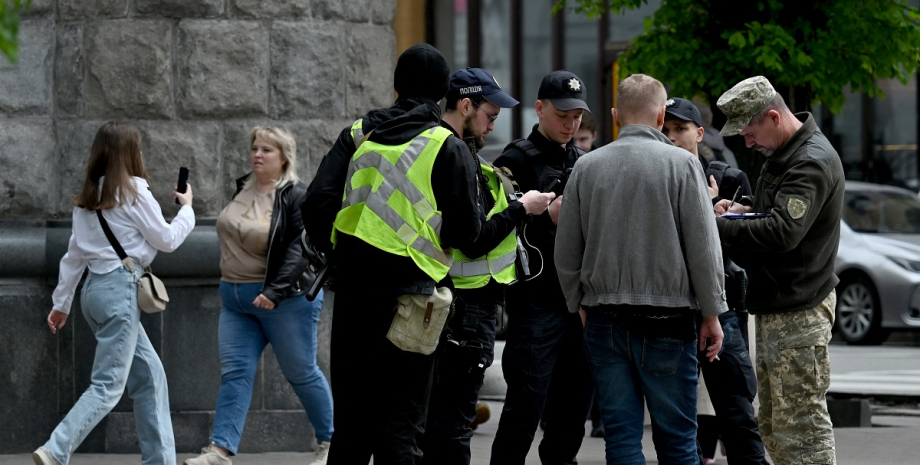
[{"x1": 45, "y1": 268, "x2": 176, "y2": 465}]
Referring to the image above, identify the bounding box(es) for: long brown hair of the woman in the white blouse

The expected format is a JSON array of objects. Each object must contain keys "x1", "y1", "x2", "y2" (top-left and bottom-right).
[{"x1": 73, "y1": 121, "x2": 147, "y2": 210}]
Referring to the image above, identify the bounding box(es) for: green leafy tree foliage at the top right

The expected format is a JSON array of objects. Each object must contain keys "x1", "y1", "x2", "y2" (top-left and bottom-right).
[{"x1": 556, "y1": 0, "x2": 920, "y2": 117}]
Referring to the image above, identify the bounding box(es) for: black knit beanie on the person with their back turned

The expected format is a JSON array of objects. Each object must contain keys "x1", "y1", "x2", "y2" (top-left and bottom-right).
[{"x1": 393, "y1": 43, "x2": 450, "y2": 102}]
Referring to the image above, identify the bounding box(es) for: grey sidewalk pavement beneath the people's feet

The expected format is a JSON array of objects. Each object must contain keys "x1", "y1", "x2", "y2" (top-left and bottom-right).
[{"x1": 0, "y1": 402, "x2": 920, "y2": 465}]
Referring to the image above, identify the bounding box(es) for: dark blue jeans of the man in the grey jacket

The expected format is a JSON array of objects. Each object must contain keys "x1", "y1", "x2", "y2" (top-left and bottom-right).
[{"x1": 585, "y1": 311, "x2": 699, "y2": 465}]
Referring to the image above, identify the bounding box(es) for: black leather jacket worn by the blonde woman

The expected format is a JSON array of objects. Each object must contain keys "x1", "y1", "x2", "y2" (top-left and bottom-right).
[{"x1": 233, "y1": 173, "x2": 314, "y2": 307}]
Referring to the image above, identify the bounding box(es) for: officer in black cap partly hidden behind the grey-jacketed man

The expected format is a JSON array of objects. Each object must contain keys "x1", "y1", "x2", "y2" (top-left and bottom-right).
[{"x1": 661, "y1": 98, "x2": 767, "y2": 465}]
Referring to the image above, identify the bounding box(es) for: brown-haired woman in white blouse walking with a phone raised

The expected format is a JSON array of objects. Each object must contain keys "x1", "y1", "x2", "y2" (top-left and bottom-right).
[{"x1": 32, "y1": 122, "x2": 195, "y2": 465}]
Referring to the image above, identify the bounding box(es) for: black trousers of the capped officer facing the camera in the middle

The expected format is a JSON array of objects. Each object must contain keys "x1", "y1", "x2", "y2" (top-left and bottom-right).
[{"x1": 490, "y1": 304, "x2": 594, "y2": 465}]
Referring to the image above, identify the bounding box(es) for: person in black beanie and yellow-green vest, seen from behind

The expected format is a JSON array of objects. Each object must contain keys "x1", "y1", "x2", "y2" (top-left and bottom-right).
[{"x1": 301, "y1": 44, "x2": 482, "y2": 465}]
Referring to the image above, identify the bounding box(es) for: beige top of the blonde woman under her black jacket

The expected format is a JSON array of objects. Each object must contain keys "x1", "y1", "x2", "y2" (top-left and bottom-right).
[{"x1": 217, "y1": 188, "x2": 275, "y2": 283}]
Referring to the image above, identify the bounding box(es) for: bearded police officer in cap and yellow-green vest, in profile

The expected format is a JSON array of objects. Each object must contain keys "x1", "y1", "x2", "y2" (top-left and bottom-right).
[{"x1": 422, "y1": 68, "x2": 555, "y2": 465}]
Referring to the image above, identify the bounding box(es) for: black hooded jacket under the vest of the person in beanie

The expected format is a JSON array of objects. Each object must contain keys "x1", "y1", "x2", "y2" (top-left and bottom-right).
[{"x1": 300, "y1": 98, "x2": 481, "y2": 297}]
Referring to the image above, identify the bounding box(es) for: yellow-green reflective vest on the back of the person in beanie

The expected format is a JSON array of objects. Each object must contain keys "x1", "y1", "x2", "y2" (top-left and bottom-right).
[{"x1": 333, "y1": 122, "x2": 453, "y2": 280}]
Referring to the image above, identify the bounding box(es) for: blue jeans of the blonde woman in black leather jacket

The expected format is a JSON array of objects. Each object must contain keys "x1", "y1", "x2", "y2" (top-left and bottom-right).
[{"x1": 211, "y1": 281, "x2": 332, "y2": 454}]
